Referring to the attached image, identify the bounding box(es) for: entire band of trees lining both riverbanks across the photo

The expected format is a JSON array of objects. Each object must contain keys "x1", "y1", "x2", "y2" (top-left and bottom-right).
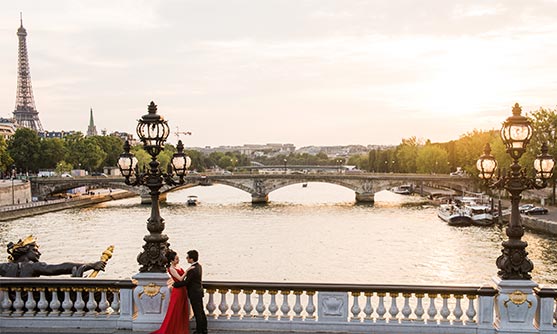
[{"x1": 0, "y1": 108, "x2": 557, "y2": 175}]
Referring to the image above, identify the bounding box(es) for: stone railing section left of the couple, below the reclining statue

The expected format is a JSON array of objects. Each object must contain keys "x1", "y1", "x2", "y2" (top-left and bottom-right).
[{"x1": 0, "y1": 278, "x2": 135, "y2": 332}]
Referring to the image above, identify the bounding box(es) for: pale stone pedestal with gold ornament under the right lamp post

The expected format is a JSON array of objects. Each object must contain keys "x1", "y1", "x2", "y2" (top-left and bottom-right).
[{"x1": 493, "y1": 277, "x2": 538, "y2": 333}]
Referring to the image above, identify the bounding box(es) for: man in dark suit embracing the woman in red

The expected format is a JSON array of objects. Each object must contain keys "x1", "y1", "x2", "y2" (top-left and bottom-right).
[{"x1": 174, "y1": 250, "x2": 207, "y2": 334}]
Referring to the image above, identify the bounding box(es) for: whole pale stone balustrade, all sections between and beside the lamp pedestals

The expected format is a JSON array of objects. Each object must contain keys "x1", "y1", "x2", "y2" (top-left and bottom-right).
[{"x1": 0, "y1": 278, "x2": 557, "y2": 333}]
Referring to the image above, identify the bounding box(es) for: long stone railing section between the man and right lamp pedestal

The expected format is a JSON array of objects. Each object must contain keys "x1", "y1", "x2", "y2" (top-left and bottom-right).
[{"x1": 204, "y1": 282, "x2": 497, "y2": 333}]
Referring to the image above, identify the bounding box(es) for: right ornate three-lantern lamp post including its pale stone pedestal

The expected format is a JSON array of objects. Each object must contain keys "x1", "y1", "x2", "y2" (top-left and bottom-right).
[{"x1": 476, "y1": 103, "x2": 555, "y2": 330}]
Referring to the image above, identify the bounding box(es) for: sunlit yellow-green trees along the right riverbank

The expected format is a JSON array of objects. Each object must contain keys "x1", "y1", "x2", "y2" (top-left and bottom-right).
[{"x1": 348, "y1": 108, "x2": 557, "y2": 175}]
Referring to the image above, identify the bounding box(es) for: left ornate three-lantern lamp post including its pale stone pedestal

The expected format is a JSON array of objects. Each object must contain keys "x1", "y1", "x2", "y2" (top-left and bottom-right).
[{"x1": 118, "y1": 102, "x2": 191, "y2": 330}]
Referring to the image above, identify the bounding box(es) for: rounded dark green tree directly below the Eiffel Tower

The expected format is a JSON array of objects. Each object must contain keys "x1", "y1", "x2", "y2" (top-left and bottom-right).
[{"x1": 8, "y1": 128, "x2": 41, "y2": 172}]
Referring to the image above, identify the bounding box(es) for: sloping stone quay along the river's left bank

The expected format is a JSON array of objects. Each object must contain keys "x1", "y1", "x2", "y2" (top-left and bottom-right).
[{"x1": 0, "y1": 191, "x2": 137, "y2": 221}]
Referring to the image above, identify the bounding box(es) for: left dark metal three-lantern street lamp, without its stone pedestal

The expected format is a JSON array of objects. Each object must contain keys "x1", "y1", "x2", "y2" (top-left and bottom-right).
[{"x1": 118, "y1": 102, "x2": 191, "y2": 273}]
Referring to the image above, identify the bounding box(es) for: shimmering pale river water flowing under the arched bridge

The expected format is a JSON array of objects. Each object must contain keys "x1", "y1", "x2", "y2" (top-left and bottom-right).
[{"x1": 0, "y1": 183, "x2": 557, "y2": 284}]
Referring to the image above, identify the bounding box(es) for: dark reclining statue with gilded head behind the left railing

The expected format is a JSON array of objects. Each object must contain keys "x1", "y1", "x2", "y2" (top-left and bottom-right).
[{"x1": 0, "y1": 235, "x2": 106, "y2": 277}]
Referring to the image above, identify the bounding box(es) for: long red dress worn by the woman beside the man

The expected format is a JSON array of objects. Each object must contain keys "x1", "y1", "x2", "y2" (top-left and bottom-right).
[{"x1": 151, "y1": 268, "x2": 190, "y2": 334}]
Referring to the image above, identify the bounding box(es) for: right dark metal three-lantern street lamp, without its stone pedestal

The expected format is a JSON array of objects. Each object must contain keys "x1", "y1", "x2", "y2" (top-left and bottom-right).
[{"x1": 476, "y1": 103, "x2": 555, "y2": 280}]
